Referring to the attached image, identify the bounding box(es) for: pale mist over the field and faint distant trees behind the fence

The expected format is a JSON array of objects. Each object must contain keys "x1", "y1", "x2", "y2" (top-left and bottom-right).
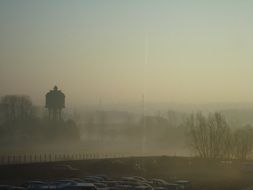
[{"x1": 1, "y1": 102, "x2": 253, "y2": 156}]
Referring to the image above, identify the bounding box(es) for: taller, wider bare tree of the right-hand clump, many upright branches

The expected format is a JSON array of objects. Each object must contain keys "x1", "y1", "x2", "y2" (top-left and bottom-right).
[{"x1": 186, "y1": 113, "x2": 231, "y2": 159}]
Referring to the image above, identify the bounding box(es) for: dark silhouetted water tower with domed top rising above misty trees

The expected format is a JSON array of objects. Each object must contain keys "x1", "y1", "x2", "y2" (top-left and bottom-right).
[{"x1": 45, "y1": 86, "x2": 65, "y2": 121}]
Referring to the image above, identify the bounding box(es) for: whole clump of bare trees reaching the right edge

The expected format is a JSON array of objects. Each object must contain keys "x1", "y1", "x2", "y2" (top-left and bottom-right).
[{"x1": 185, "y1": 112, "x2": 253, "y2": 160}]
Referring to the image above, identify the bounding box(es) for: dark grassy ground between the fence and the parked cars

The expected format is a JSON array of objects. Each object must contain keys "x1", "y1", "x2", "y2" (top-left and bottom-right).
[{"x1": 0, "y1": 156, "x2": 253, "y2": 190}]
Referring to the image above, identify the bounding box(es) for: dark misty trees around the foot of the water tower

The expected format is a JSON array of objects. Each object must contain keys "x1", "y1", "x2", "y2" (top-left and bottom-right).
[{"x1": 0, "y1": 95, "x2": 80, "y2": 144}]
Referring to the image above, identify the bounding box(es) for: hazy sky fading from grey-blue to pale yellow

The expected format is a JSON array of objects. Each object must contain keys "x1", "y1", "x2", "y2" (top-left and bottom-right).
[{"x1": 0, "y1": 0, "x2": 253, "y2": 105}]
